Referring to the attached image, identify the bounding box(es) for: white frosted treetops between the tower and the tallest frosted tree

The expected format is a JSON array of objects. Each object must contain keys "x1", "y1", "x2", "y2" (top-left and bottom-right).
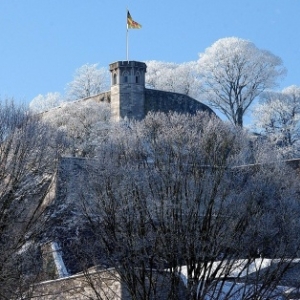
[{"x1": 146, "y1": 60, "x2": 199, "y2": 98}]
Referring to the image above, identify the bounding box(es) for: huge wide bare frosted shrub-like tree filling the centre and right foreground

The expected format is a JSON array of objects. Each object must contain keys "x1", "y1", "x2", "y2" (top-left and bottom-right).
[{"x1": 57, "y1": 113, "x2": 300, "y2": 300}]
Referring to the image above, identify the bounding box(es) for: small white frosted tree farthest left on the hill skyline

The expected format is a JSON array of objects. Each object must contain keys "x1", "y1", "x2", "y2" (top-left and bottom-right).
[{"x1": 29, "y1": 92, "x2": 64, "y2": 113}]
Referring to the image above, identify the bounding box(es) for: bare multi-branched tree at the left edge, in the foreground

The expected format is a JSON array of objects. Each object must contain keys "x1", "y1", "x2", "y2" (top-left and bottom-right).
[{"x1": 0, "y1": 101, "x2": 64, "y2": 299}]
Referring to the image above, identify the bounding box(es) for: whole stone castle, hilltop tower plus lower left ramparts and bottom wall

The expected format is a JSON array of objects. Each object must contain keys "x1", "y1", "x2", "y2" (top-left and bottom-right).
[{"x1": 19, "y1": 61, "x2": 219, "y2": 300}]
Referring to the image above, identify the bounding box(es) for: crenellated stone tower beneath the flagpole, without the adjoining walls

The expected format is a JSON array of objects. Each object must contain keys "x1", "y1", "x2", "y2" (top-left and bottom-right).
[{"x1": 109, "y1": 61, "x2": 147, "y2": 121}]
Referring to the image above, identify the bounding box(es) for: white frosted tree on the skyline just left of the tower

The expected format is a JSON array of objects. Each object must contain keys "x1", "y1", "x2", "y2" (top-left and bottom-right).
[{"x1": 66, "y1": 64, "x2": 109, "y2": 100}]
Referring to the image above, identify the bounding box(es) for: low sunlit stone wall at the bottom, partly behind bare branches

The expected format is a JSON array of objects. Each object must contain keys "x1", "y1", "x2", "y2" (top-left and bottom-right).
[{"x1": 27, "y1": 268, "x2": 186, "y2": 300}]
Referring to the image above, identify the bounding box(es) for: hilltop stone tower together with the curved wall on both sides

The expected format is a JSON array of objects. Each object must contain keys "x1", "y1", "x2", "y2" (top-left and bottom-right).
[{"x1": 89, "y1": 61, "x2": 213, "y2": 121}]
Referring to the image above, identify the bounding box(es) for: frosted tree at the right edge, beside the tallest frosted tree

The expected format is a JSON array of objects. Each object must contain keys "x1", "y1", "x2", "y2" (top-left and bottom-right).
[{"x1": 253, "y1": 85, "x2": 300, "y2": 157}]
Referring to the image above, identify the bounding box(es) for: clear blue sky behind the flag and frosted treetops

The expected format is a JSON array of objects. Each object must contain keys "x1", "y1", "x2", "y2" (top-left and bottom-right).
[{"x1": 0, "y1": 0, "x2": 300, "y2": 103}]
